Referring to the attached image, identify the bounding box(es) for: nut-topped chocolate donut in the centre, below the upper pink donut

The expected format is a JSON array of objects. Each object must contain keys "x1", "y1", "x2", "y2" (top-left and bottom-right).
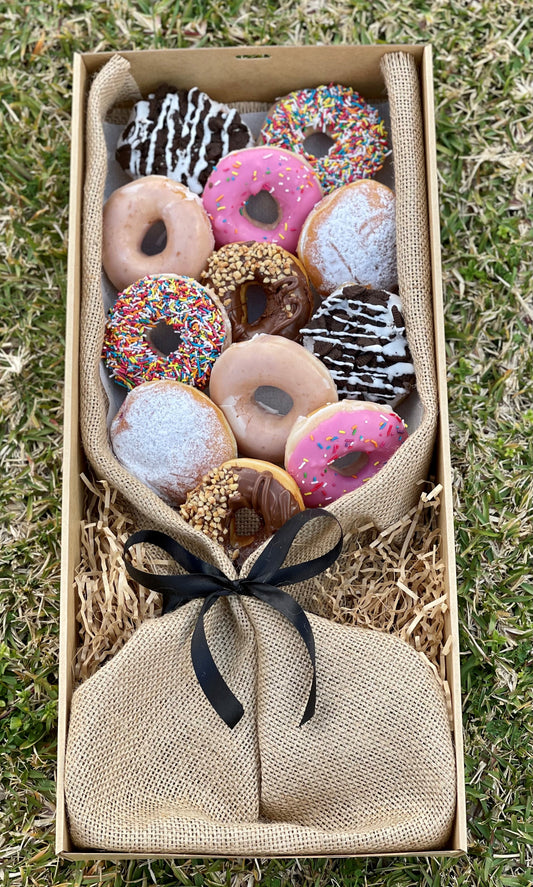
[{"x1": 201, "y1": 240, "x2": 313, "y2": 342}]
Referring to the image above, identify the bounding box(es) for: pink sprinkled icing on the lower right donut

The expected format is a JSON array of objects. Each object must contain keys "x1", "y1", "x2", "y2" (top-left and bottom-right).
[{"x1": 285, "y1": 409, "x2": 407, "y2": 508}]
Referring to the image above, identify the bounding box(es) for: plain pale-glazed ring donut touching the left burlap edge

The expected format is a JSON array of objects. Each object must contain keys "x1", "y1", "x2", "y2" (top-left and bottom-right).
[{"x1": 102, "y1": 176, "x2": 214, "y2": 290}]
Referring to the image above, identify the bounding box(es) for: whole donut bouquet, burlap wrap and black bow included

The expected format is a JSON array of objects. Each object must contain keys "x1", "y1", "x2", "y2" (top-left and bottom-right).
[{"x1": 65, "y1": 53, "x2": 456, "y2": 857}]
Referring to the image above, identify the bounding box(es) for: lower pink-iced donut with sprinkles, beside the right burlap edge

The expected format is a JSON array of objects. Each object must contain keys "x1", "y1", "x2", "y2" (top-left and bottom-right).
[{"x1": 285, "y1": 400, "x2": 407, "y2": 508}]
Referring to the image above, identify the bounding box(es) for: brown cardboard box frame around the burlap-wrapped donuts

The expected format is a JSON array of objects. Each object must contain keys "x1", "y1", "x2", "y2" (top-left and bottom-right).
[{"x1": 56, "y1": 45, "x2": 467, "y2": 860}]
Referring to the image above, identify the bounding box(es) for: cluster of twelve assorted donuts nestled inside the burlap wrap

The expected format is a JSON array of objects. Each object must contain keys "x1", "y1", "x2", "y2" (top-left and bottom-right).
[{"x1": 97, "y1": 84, "x2": 415, "y2": 565}]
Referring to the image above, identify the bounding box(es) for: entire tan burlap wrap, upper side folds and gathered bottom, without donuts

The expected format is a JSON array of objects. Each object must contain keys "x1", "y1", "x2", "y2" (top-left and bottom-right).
[{"x1": 65, "y1": 53, "x2": 455, "y2": 856}]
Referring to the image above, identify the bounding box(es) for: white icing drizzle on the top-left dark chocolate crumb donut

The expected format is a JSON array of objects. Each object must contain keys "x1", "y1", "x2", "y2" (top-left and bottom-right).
[{"x1": 117, "y1": 86, "x2": 253, "y2": 194}]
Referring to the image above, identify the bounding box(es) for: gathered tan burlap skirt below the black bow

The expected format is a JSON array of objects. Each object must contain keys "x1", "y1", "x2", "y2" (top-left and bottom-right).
[{"x1": 65, "y1": 597, "x2": 455, "y2": 856}]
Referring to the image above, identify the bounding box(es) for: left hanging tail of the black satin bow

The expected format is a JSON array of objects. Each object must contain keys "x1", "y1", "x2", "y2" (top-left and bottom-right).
[{"x1": 191, "y1": 594, "x2": 244, "y2": 730}]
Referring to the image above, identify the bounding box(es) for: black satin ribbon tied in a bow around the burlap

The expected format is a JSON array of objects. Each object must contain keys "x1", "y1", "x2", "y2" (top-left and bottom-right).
[{"x1": 124, "y1": 510, "x2": 343, "y2": 728}]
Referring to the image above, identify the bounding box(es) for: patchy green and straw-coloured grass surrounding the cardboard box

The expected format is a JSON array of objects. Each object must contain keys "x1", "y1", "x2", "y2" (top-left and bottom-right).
[{"x1": 0, "y1": 0, "x2": 533, "y2": 887}]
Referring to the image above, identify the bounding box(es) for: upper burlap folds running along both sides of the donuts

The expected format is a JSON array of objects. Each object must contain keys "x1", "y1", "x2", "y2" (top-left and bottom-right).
[{"x1": 80, "y1": 53, "x2": 437, "y2": 575}]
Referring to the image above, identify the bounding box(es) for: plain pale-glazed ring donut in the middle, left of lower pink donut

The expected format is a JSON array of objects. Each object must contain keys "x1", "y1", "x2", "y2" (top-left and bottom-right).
[{"x1": 209, "y1": 333, "x2": 337, "y2": 463}]
